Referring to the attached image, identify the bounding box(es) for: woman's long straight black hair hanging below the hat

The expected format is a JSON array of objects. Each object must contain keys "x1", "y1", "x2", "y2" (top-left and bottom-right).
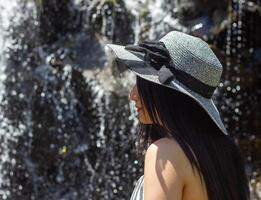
[{"x1": 136, "y1": 76, "x2": 250, "y2": 200}]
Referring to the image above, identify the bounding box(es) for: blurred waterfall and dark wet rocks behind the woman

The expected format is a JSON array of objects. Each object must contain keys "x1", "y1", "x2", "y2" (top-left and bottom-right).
[{"x1": 0, "y1": 0, "x2": 261, "y2": 200}]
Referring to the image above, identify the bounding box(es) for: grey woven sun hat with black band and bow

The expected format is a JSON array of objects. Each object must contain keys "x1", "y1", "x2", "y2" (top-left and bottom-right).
[{"x1": 108, "y1": 31, "x2": 228, "y2": 134}]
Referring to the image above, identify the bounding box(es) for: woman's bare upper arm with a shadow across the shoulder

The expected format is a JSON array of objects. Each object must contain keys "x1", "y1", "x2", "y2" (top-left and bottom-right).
[{"x1": 144, "y1": 138, "x2": 184, "y2": 200}]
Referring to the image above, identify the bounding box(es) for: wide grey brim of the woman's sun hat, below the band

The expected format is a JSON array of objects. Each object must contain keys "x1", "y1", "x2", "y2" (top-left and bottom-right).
[{"x1": 106, "y1": 44, "x2": 228, "y2": 135}]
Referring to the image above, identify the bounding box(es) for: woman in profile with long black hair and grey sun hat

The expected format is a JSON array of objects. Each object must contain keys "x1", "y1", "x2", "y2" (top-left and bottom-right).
[{"x1": 108, "y1": 31, "x2": 249, "y2": 200}]
